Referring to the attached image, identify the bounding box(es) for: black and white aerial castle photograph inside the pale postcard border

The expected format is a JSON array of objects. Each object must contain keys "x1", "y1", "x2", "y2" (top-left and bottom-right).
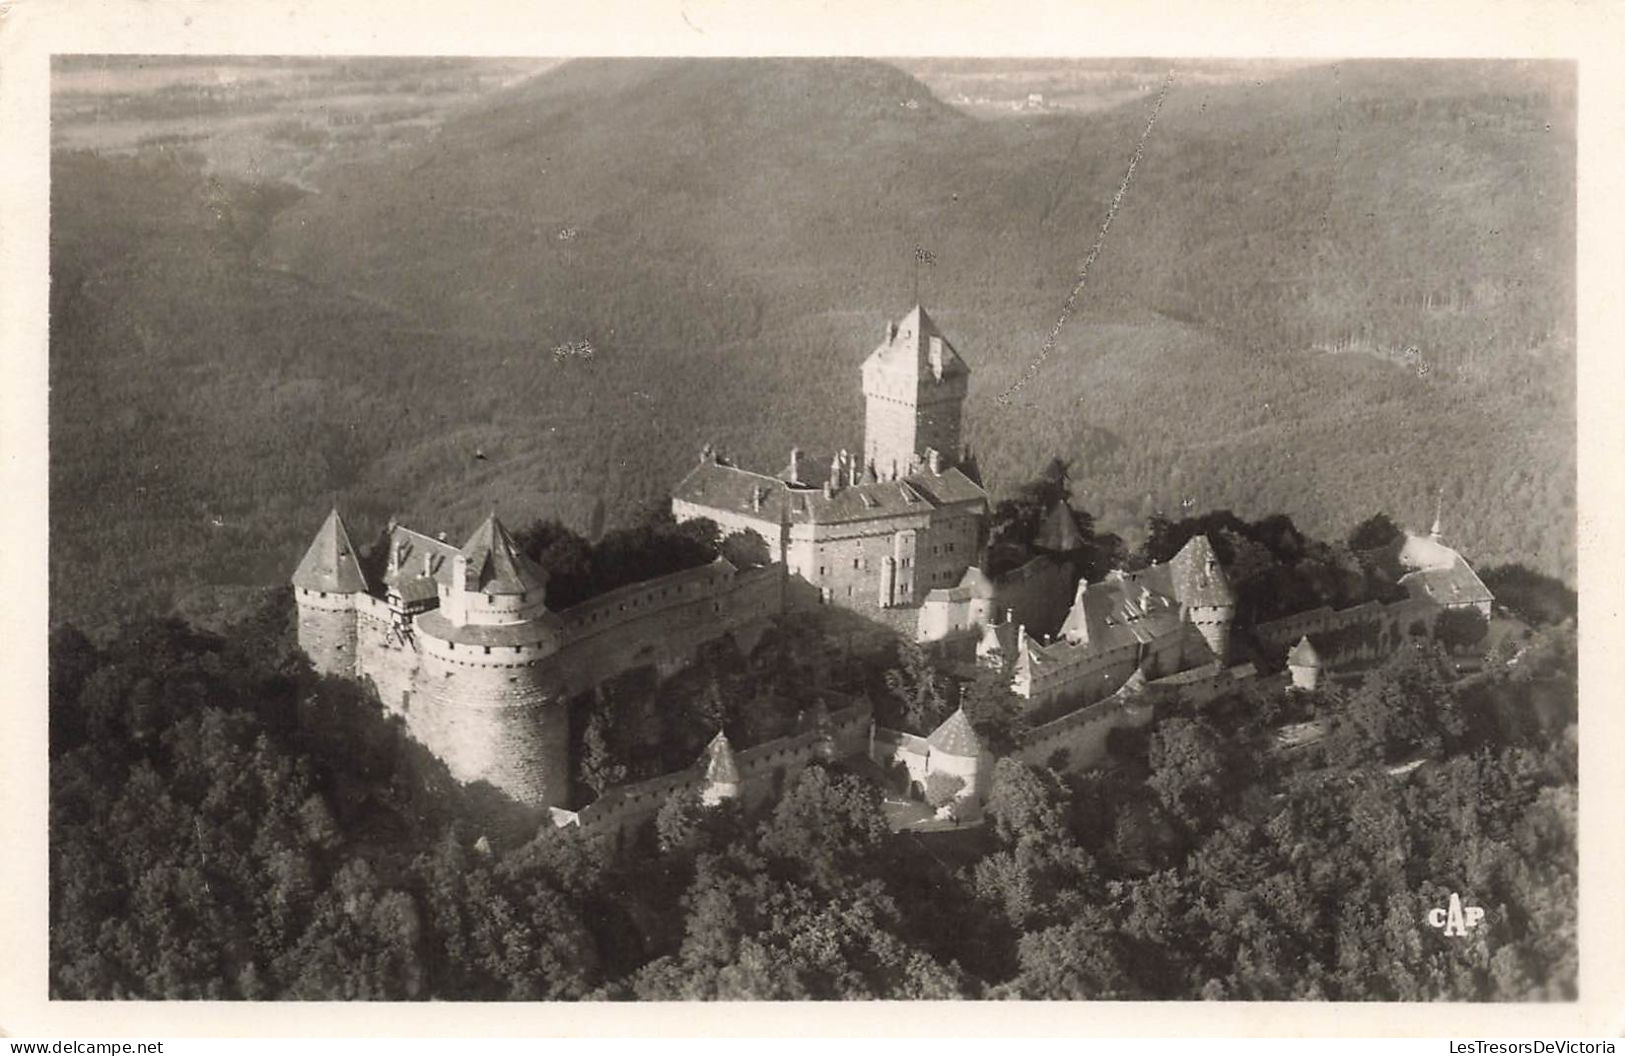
[{"x1": 11, "y1": 0, "x2": 1619, "y2": 1033}]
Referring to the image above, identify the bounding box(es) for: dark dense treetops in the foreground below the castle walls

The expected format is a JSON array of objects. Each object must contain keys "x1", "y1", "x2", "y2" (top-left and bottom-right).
[{"x1": 50, "y1": 500, "x2": 1578, "y2": 1001}]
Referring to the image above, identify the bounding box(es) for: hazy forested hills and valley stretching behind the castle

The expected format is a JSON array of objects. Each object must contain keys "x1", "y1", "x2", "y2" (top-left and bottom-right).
[{"x1": 50, "y1": 62, "x2": 1575, "y2": 634}]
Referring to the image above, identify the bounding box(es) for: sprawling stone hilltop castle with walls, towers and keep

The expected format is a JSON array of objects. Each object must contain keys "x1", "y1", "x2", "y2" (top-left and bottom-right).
[{"x1": 293, "y1": 300, "x2": 1490, "y2": 832}]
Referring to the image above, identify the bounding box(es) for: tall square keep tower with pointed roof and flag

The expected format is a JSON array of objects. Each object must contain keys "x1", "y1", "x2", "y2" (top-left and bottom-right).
[{"x1": 863, "y1": 305, "x2": 970, "y2": 481}]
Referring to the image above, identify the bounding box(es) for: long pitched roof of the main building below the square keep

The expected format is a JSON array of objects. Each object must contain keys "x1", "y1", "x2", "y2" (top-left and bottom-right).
[{"x1": 671, "y1": 460, "x2": 988, "y2": 526}]
